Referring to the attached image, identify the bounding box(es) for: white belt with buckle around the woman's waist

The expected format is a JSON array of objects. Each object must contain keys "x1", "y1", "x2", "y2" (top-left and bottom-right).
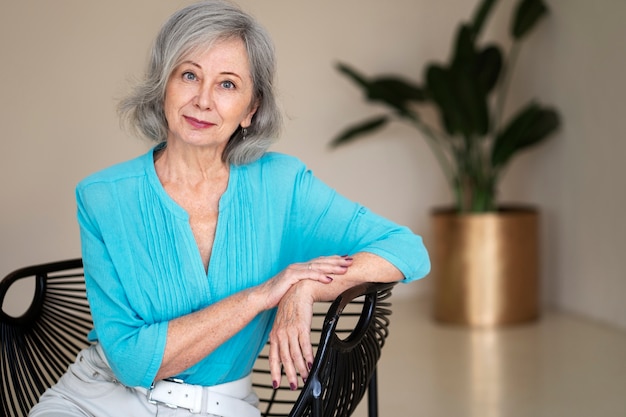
[{"x1": 141, "y1": 375, "x2": 261, "y2": 417}]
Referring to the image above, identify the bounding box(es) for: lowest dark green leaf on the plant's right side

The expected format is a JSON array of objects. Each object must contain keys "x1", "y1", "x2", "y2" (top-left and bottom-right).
[{"x1": 491, "y1": 103, "x2": 560, "y2": 168}]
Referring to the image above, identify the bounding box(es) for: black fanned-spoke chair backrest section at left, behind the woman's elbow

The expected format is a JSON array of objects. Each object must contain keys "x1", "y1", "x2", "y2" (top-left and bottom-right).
[{"x1": 0, "y1": 259, "x2": 92, "y2": 417}]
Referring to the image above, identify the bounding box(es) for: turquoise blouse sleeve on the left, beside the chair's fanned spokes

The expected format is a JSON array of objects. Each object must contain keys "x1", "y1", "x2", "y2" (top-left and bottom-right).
[{"x1": 76, "y1": 182, "x2": 167, "y2": 388}]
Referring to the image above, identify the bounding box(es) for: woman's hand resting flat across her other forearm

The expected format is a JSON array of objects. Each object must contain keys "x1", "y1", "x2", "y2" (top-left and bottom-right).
[{"x1": 257, "y1": 256, "x2": 350, "y2": 310}]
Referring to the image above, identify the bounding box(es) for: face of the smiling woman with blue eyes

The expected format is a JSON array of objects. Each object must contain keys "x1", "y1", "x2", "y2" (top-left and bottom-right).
[{"x1": 164, "y1": 39, "x2": 257, "y2": 150}]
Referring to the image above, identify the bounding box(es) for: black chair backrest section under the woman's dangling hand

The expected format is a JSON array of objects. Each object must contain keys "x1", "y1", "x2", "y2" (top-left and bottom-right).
[{"x1": 253, "y1": 283, "x2": 394, "y2": 417}]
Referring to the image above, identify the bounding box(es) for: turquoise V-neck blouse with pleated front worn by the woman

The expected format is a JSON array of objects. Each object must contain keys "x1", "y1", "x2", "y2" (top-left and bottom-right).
[{"x1": 76, "y1": 145, "x2": 430, "y2": 387}]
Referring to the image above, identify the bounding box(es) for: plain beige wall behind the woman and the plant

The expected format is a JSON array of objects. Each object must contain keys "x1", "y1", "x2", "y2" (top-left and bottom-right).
[{"x1": 0, "y1": 0, "x2": 626, "y2": 328}]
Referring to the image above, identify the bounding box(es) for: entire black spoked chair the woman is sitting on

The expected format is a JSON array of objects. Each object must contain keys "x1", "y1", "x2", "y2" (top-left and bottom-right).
[{"x1": 0, "y1": 259, "x2": 393, "y2": 417}]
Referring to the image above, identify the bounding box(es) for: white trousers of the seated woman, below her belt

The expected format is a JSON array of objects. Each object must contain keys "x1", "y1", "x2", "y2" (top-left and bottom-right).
[{"x1": 29, "y1": 345, "x2": 258, "y2": 417}]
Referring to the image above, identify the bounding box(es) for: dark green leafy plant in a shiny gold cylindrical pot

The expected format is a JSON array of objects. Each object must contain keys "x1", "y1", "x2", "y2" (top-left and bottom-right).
[{"x1": 331, "y1": 0, "x2": 560, "y2": 325}]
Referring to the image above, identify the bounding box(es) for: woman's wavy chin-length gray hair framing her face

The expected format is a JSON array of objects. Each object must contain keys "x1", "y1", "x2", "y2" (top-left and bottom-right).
[{"x1": 118, "y1": 0, "x2": 282, "y2": 165}]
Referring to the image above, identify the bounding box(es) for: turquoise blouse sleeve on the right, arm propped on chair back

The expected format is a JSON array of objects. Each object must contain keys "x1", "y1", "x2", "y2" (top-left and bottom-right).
[{"x1": 280, "y1": 156, "x2": 430, "y2": 282}]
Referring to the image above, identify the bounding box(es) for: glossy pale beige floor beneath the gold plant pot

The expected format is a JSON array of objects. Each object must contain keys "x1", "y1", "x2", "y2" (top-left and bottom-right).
[{"x1": 354, "y1": 297, "x2": 626, "y2": 417}]
